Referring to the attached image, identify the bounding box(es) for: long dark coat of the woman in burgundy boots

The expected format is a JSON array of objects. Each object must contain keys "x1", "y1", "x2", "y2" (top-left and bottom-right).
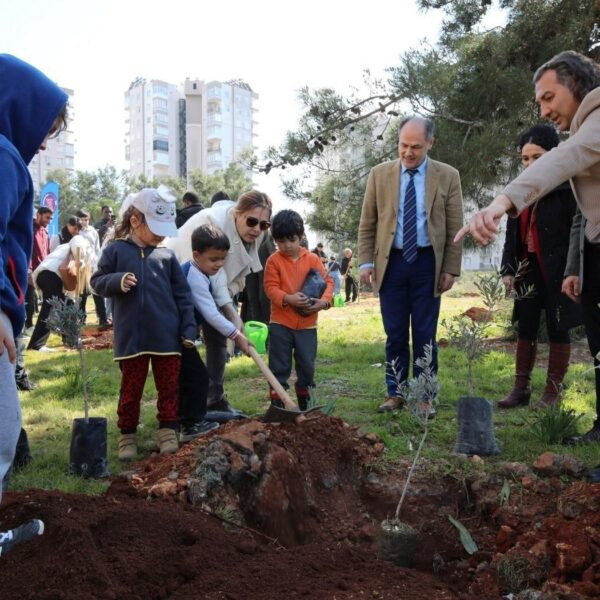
[{"x1": 501, "y1": 182, "x2": 581, "y2": 330}]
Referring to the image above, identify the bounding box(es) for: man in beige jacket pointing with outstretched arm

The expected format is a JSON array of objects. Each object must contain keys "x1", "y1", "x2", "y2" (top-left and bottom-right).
[{"x1": 456, "y1": 50, "x2": 600, "y2": 454}]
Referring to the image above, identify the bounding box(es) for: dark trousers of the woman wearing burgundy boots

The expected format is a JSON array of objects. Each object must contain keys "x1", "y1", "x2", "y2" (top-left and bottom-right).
[{"x1": 517, "y1": 253, "x2": 571, "y2": 344}]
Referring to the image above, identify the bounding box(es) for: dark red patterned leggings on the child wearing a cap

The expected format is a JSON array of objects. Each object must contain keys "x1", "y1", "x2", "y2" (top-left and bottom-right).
[{"x1": 117, "y1": 354, "x2": 181, "y2": 433}]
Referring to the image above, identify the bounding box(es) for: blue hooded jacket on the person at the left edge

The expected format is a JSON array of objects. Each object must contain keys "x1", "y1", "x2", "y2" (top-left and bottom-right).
[{"x1": 0, "y1": 54, "x2": 68, "y2": 336}]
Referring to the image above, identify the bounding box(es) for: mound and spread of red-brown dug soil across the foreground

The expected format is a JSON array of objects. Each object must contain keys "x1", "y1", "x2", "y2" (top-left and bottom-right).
[{"x1": 0, "y1": 417, "x2": 600, "y2": 600}]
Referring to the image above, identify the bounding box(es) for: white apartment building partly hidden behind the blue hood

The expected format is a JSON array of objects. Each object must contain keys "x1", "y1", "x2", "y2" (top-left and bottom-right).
[{"x1": 29, "y1": 88, "x2": 75, "y2": 193}]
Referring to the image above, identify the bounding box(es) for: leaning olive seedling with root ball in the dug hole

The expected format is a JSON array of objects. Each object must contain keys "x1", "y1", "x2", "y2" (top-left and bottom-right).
[{"x1": 379, "y1": 344, "x2": 440, "y2": 567}]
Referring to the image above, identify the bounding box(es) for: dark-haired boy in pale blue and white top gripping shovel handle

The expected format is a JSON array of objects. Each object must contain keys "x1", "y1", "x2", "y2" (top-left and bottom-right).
[{"x1": 179, "y1": 225, "x2": 249, "y2": 442}]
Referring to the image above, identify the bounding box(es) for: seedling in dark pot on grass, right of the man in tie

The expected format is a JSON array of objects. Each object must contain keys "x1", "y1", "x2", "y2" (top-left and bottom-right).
[{"x1": 442, "y1": 263, "x2": 533, "y2": 455}]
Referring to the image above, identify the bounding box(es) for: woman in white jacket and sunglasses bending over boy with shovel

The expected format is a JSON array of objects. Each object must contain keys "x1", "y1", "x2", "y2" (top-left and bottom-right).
[{"x1": 167, "y1": 190, "x2": 272, "y2": 411}]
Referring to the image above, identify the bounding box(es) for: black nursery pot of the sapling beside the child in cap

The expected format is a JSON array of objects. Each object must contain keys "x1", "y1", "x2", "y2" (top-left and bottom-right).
[{"x1": 69, "y1": 417, "x2": 108, "y2": 479}]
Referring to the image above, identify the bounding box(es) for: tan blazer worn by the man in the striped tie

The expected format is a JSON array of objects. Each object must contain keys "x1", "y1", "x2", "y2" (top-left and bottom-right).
[{"x1": 358, "y1": 158, "x2": 463, "y2": 296}]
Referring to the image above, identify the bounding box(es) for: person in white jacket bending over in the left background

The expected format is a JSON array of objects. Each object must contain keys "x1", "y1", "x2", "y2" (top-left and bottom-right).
[{"x1": 27, "y1": 234, "x2": 93, "y2": 352}]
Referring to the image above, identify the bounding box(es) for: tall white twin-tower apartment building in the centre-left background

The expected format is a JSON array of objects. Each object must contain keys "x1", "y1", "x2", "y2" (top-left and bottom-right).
[{"x1": 125, "y1": 79, "x2": 258, "y2": 177}]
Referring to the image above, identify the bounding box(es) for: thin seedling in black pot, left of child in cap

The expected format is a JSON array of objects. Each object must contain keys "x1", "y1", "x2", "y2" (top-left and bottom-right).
[{"x1": 46, "y1": 298, "x2": 108, "y2": 479}]
